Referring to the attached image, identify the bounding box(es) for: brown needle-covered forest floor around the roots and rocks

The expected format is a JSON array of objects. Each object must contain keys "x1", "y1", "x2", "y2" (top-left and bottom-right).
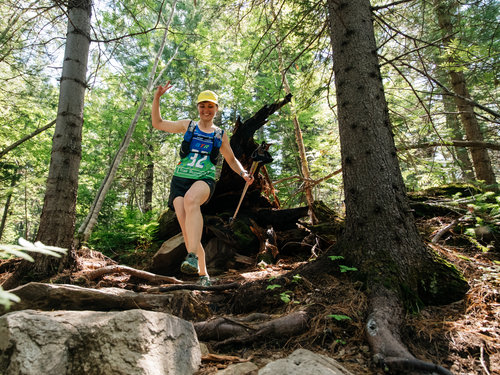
[{"x1": 0, "y1": 217, "x2": 500, "y2": 375}]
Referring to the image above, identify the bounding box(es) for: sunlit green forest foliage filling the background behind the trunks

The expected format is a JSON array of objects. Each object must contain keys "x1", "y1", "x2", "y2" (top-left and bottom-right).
[{"x1": 0, "y1": 0, "x2": 500, "y2": 264}]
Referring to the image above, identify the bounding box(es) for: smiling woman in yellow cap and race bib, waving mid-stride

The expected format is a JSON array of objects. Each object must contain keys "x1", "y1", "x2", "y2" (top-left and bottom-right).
[{"x1": 151, "y1": 81, "x2": 254, "y2": 286}]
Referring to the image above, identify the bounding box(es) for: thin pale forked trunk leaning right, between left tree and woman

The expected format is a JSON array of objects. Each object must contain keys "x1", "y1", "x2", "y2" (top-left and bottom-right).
[{"x1": 78, "y1": 1, "x2": 177, "y2": 243}]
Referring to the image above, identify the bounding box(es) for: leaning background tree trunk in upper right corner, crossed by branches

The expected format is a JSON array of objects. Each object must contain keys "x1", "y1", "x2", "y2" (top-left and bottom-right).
[{"x1": 434, "y1": 0, "x2": 496, "y2": 185}]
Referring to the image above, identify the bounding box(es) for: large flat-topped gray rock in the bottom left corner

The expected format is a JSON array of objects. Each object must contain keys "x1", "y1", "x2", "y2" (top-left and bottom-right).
[{"x1": 0, "y1": 310, "x2": 201, "y2": 375}]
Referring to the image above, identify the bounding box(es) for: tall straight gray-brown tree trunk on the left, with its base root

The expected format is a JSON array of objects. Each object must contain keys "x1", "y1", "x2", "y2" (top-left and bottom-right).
[{"x1": 3, "y1": 0, "x2": 92, "y2": 289}]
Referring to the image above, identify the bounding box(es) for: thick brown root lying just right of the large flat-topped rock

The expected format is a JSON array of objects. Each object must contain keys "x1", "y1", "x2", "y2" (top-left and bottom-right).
[{"x1": 194, "y1": 311, "x2": 309, "y2": 348}]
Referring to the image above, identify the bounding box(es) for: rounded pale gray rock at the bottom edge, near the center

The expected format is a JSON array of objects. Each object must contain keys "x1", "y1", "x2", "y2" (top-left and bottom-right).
[{"x1": 258, "y1": 349, "x2": 353, "y2": 375}]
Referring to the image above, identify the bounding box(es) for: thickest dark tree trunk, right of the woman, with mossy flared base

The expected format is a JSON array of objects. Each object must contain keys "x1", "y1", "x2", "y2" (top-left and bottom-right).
[{"x1": 322, "y1": 0, "x2": 467, "y2": 367}]
